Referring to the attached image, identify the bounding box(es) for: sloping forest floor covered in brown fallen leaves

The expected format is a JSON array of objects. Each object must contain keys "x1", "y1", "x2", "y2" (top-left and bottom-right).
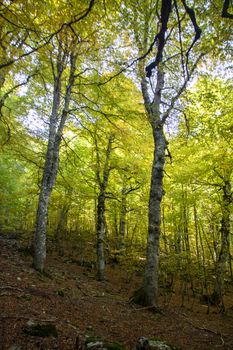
[{"x1": 0, "y1": 232, "x2": 233, "y2": 350}]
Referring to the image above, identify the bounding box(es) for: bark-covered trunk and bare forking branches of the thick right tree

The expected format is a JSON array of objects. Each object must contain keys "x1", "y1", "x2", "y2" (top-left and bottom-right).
[{"x1": 133, "y1": 0, "x2": 202, "y2": 306}]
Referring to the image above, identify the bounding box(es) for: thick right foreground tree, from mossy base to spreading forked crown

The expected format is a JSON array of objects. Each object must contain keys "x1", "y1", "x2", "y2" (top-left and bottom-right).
[{"x1": 124, "y1": 1, "x2": 202, "y2": 306}]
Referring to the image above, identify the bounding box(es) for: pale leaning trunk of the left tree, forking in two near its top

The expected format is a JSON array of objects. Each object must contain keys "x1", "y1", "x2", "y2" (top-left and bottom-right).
[{"x1": 33, "y1": 51, "x2": 77, "y2": 272}]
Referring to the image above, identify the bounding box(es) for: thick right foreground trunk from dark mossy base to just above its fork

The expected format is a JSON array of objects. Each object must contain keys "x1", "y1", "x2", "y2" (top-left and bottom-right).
[{"x1": 133, "y1": 65, "x2": 167, "y2": 307}]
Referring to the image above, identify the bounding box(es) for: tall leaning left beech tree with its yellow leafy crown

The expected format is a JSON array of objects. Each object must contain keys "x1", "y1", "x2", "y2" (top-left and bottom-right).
[{"x1": 30, "y1": 0, "x2": 115, "y2": 271}]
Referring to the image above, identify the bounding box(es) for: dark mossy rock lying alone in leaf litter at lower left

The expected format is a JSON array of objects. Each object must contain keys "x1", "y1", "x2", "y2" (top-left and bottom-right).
[{"x1": 23, "y1": 321, "x2": 58, "y2": 338}]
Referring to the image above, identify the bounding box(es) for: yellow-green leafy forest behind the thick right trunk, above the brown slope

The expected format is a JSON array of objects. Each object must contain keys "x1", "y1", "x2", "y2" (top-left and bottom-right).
[{"x1": 0, "y1": 0, "x2": 233, "y2": 310}]
